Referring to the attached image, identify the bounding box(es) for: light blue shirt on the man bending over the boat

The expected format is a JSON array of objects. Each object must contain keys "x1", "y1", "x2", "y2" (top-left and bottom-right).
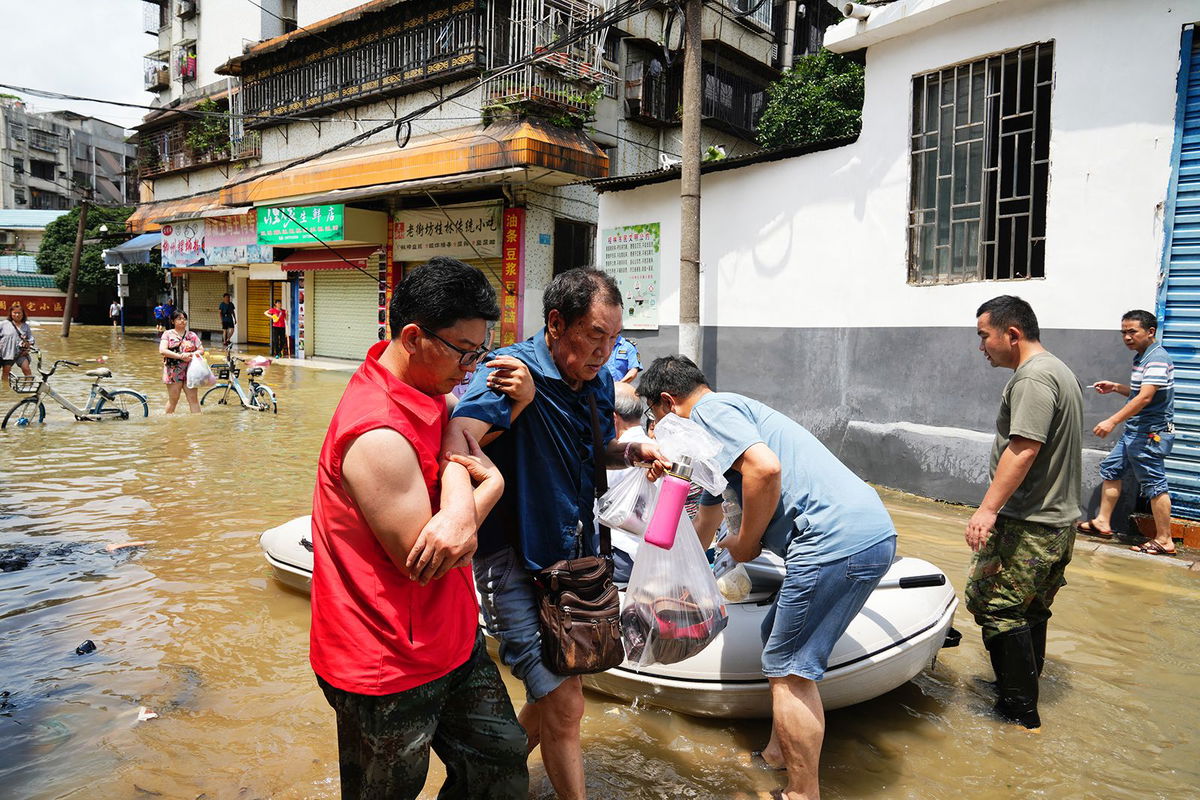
[{"x1": 691, "y1": 392, "x2": 896, "y2": 564}]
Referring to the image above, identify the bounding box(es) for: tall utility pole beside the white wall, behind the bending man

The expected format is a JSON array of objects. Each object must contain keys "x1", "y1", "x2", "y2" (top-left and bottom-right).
[{"x1": 679, "y1": 0, "x2": 704, "y2": 365}]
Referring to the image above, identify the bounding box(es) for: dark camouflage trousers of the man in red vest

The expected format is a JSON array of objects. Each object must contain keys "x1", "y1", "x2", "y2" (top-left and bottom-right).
[{"x1": 317, "y1": 632, "x2": 529, "y2": 800}]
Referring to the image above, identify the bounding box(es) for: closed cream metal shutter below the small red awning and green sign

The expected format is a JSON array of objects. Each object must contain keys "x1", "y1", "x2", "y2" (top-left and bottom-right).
[{"x1": 307, "y1": 270, "x2": 379, "y2": 360}]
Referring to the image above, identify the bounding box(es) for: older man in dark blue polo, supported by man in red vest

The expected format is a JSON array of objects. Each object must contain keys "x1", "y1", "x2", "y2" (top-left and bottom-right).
[{"x1": 445, "y1": 267, "x2": 665, "y2": 800}]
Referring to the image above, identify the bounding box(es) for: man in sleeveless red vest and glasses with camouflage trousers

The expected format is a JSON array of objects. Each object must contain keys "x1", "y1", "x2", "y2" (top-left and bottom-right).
[{"x1": 310, "y1": 258, "x2": 533, "y2": 800}]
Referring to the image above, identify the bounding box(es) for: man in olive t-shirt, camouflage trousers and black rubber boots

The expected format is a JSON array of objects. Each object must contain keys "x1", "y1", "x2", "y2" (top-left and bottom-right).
[{"x1": 966, "y1": 295, "x2": 1084, "y2": 728}]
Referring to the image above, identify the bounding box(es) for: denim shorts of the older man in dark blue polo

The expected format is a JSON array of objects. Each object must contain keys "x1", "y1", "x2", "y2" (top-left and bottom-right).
[{"x1": 474, "y1": 547, "x2": 566, "y2": 703}]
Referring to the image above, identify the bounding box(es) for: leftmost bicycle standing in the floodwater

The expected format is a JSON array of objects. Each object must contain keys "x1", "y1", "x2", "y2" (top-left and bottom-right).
[{"x1": 0, "y1": 348, "x2": 150, "y2": 429}]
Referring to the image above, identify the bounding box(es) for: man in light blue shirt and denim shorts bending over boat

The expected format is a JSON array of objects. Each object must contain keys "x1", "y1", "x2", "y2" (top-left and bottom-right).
[{"x1": 637, "y1": 356, "x2": 896, "y2": 800}]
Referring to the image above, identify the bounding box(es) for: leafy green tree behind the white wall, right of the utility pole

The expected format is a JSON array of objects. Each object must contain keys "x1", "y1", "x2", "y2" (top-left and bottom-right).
[{"x1": 758, "y1": 50, "x2": 863, "y2": 148}]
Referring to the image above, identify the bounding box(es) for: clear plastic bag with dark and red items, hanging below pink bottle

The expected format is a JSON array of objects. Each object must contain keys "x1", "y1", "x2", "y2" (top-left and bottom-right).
[{"x1": 620, "y1": 513, "x2": 728, "y2": 667}]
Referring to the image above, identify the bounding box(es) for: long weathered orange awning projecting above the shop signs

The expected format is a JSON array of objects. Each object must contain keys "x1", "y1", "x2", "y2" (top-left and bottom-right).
[{"x1": 221, "y1": 119, "x2": 608, "y2": 206}]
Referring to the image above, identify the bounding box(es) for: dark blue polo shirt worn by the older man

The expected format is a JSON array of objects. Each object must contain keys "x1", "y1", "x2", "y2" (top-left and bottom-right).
[{"x1": 454, "y1": 329, "x2": 616, "y2": 570}]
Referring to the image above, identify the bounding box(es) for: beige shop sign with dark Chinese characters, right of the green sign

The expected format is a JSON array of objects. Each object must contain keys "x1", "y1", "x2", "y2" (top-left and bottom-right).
[{"x1": 392, "y1": 203, "x2": 502, "y2": 261}]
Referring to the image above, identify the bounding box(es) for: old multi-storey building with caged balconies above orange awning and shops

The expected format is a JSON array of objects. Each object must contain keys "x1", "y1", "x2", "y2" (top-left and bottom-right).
[{"x1": 131, "y1": 0, "x2": 830, "y2": 357}]
